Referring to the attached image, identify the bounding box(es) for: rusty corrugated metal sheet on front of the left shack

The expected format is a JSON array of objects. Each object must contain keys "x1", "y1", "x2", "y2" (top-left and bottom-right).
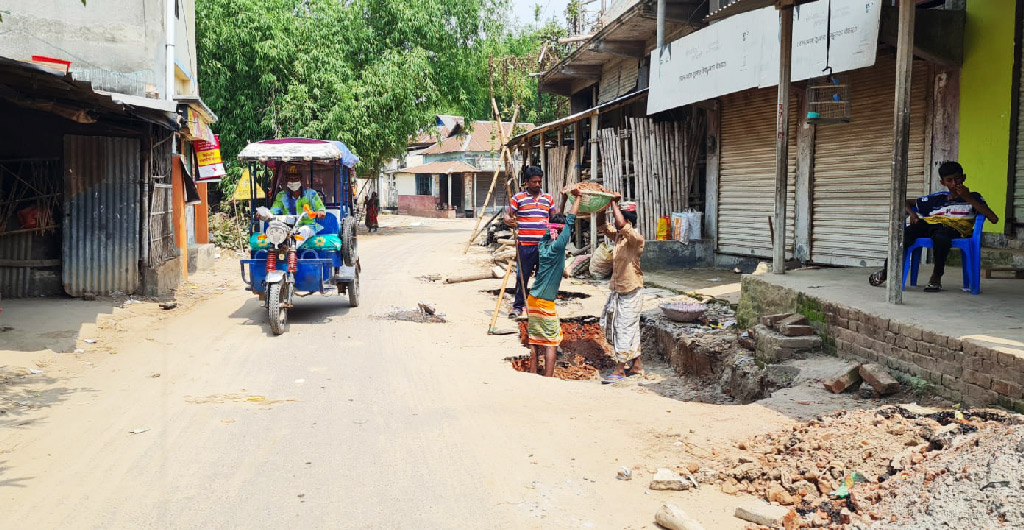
[{"x1": 63, "y1": 135, "x2": 140, "y2": 296}]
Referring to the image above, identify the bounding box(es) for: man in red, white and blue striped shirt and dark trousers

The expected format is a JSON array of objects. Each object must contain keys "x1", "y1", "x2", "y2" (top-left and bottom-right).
[{"x1": 505, "y1": 166, "x2": 558, "y2": 318}]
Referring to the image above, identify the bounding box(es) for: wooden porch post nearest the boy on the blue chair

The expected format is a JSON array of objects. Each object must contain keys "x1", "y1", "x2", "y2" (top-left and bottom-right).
[{"x1": 887, "y1": 0, "x2": 916, "y2": 304}]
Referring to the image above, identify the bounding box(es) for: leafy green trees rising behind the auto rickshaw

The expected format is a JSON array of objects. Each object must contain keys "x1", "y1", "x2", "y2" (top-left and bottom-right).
[{"x1": 196, "y1": 0, "x2": 564, "y2": 179}]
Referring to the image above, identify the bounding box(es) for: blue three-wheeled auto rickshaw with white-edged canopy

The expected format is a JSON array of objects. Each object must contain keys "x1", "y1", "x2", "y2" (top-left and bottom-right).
[{"x1": 239, "y1": 138, "x2": 359, "y2": 335}]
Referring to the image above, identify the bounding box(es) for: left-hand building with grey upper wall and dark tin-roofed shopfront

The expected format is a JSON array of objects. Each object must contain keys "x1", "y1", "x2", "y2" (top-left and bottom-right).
[{"x1": 0, "y1": 0, "x2": 216, "y2": 297}]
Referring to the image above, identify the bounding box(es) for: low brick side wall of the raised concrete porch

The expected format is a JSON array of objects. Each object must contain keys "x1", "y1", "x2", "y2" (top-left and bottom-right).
[{"x1": 822, "y1": 302, "x2": 1024, "y2": 412}]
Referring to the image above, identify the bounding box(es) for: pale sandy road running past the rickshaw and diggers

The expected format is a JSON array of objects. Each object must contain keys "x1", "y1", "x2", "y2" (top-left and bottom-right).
[{"x1": 0, "y1": 218, "x2": 791, "y2": 529}]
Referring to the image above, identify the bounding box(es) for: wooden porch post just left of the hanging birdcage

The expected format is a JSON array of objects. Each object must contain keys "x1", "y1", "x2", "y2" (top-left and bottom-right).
[{"x1": 771, "y1": 5, "x2": 793, "y2": 274}]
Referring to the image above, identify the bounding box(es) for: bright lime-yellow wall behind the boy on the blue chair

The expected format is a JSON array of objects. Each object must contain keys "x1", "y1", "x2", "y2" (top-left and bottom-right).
[{"x1": 959, "y1": 0, "x2": 1016, "y2": 232}]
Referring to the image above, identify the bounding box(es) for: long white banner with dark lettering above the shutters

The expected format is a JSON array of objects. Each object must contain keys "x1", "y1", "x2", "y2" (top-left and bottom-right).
[{"x1": 647, "y1": 0, "x2": 882, "y2": 115}]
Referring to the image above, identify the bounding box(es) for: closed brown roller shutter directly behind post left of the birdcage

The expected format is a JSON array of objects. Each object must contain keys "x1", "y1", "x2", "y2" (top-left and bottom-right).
[{"x1": 718, "y1": 88, "x2": 800, "y2": 258}]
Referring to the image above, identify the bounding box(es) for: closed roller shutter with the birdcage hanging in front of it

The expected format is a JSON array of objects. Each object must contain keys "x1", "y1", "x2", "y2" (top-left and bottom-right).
[{"x1": 811, "y1": 57, "x2": 931, "y2": 266}]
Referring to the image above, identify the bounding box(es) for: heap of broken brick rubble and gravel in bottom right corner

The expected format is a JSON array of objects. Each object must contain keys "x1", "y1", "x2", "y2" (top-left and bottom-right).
[{"x1": 700, "y1": 405, "x2": 1024, "y2": 529}]
